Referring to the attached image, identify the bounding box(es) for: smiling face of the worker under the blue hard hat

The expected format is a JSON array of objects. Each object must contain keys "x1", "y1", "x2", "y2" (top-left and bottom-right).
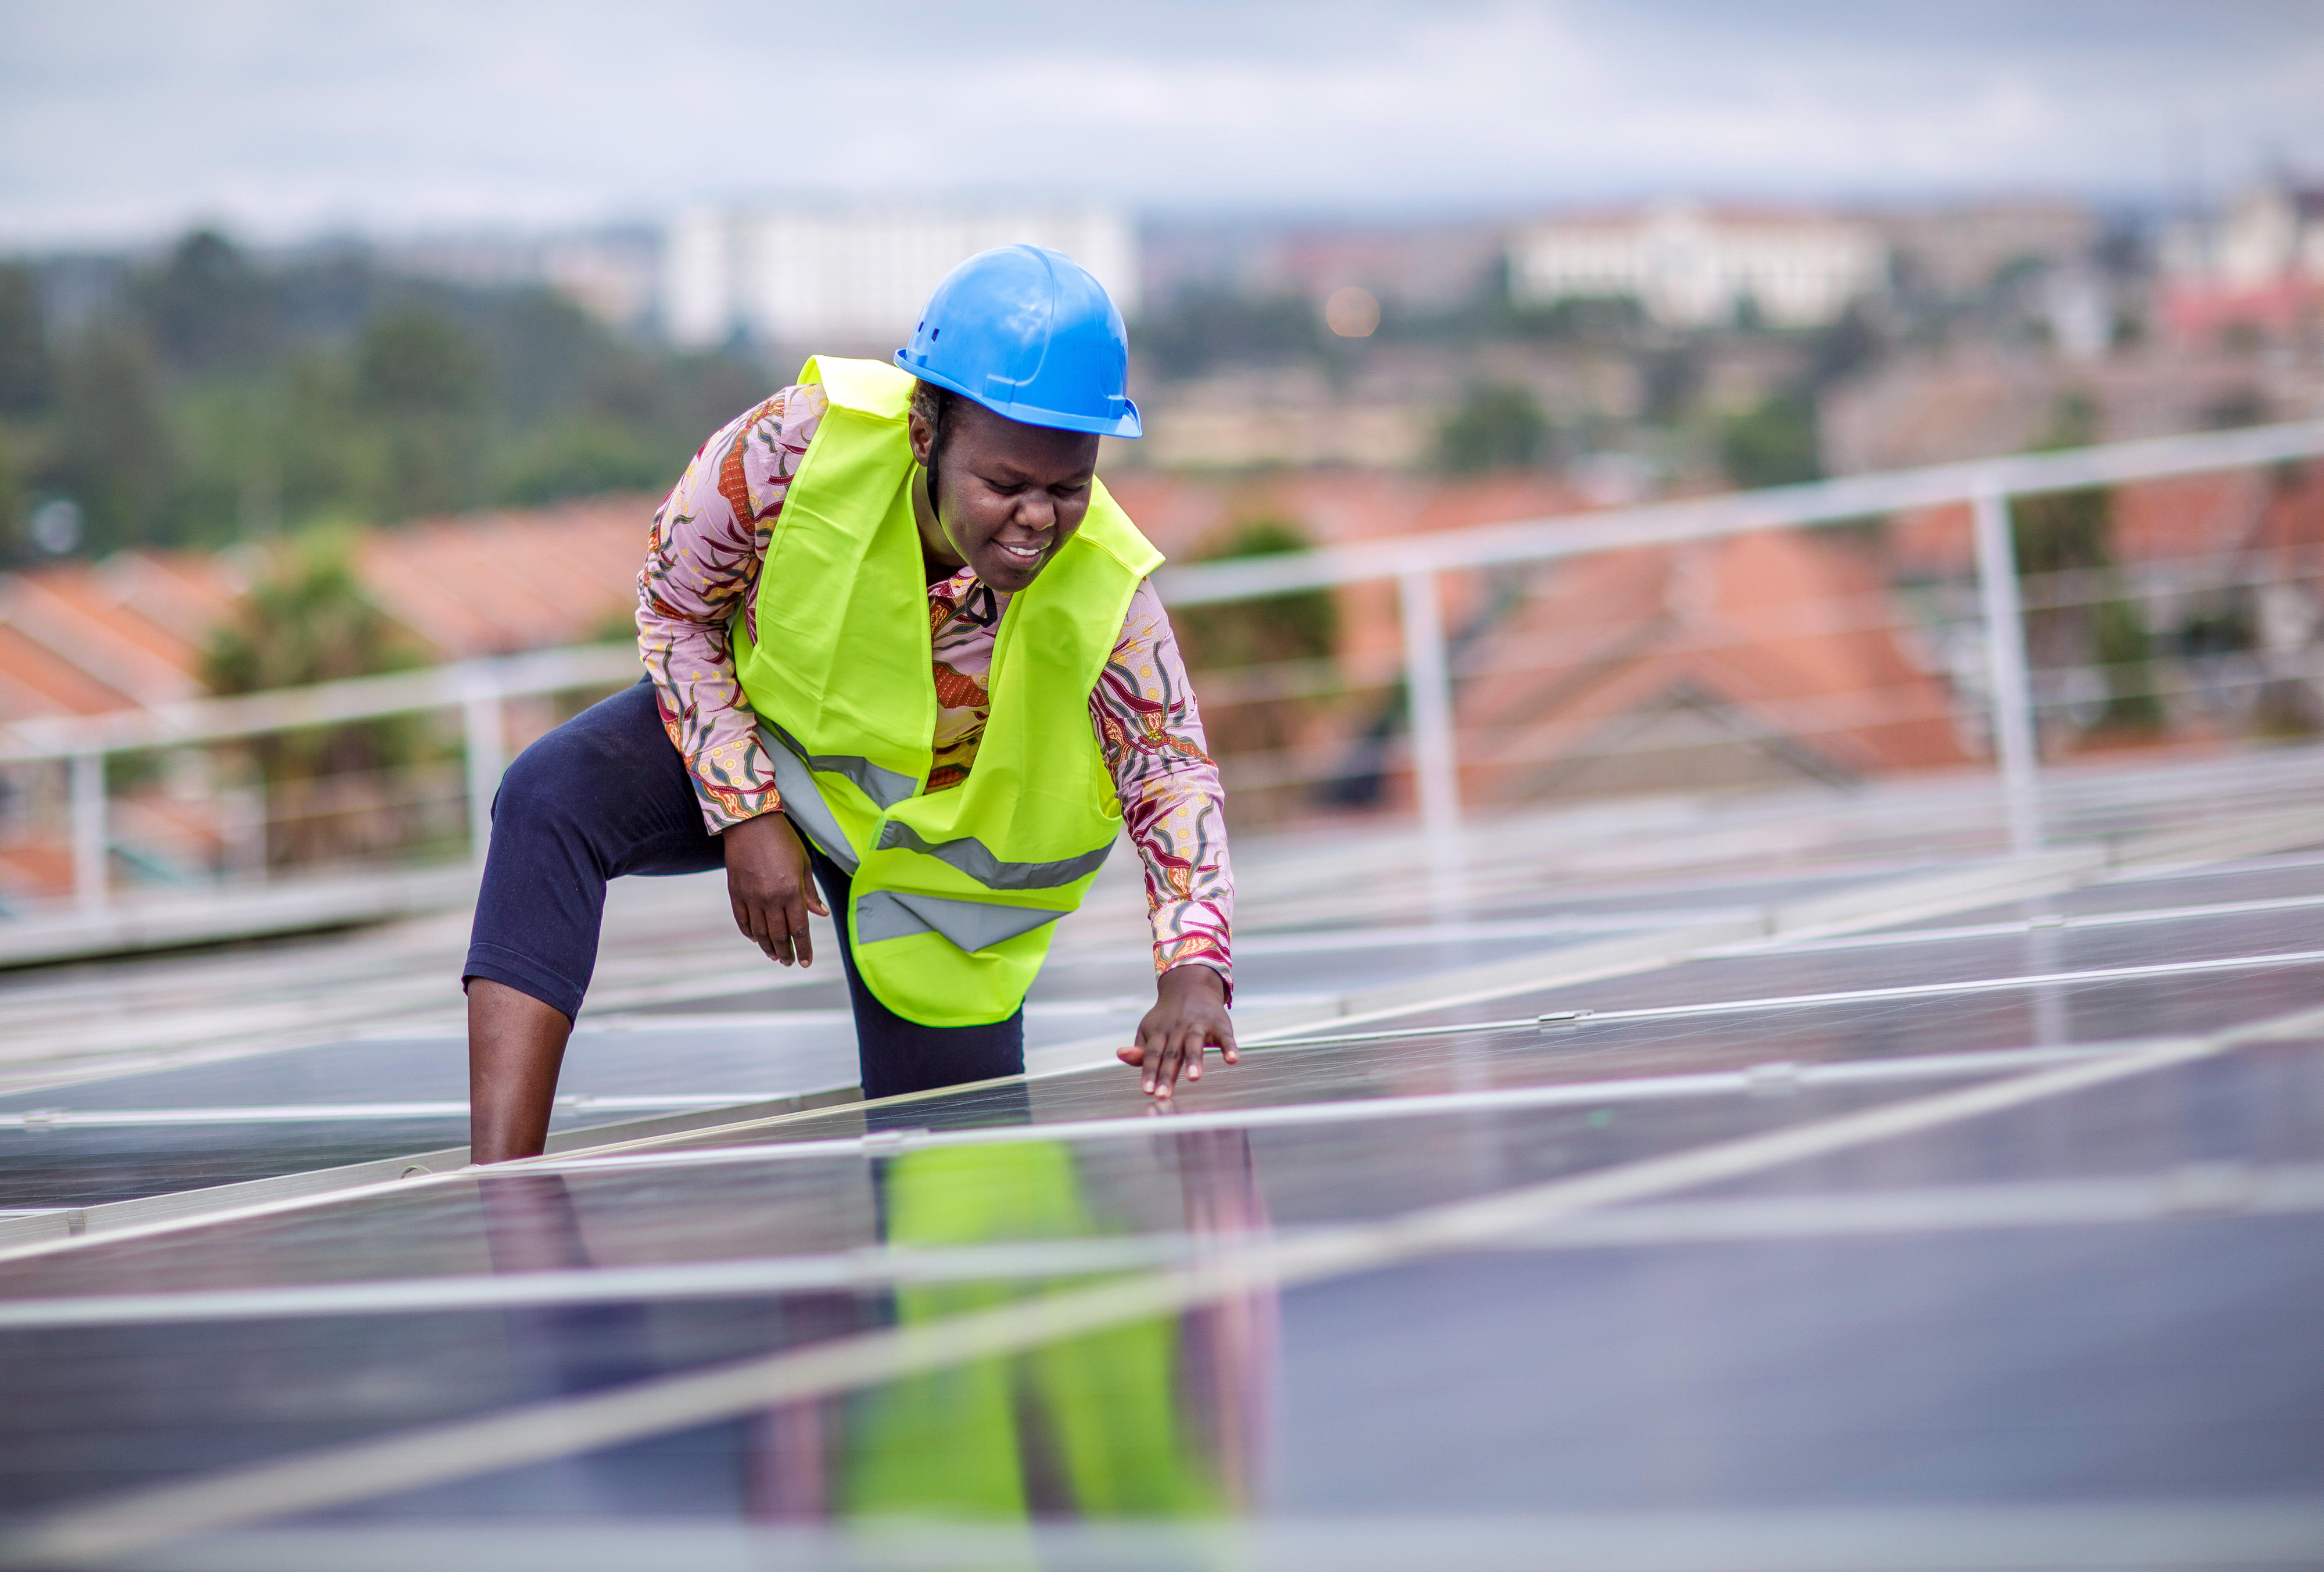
[{"x1": 911, "y1": 398, "x2": 1097, "y2": 595}]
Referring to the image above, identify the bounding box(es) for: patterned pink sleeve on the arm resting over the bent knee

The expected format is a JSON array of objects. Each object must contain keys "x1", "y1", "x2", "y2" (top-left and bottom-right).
[{"x1": 637, "y1": 386, "x2": 825, "y2": 835}]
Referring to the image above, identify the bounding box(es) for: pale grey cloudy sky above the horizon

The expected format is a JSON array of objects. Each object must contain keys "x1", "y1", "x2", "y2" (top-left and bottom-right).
[{"x1": 0, "y1": 0, "x2": 2324, "y2": 246}]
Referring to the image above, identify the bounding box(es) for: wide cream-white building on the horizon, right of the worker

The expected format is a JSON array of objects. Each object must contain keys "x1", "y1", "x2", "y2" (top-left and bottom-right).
[{"x1": 1508, "y1": 202, "x2": 1887, "y2": 328}]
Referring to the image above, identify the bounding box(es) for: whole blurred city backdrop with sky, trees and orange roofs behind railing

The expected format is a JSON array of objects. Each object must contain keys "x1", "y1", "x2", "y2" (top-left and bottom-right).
[{"x1": 0, "y1": 5, "x2": 2324, "y2": 903}]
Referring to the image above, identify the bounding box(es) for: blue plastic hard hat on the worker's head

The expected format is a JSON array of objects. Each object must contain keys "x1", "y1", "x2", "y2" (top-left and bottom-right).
[{"x1": 895, "y1": 246, "x2": 1146, "y2": 437}]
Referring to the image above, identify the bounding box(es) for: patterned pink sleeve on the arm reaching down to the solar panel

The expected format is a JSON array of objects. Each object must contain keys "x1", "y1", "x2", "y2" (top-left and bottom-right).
[{"x1": 1090, "y1": 583, "x2": 1234, "y2": 998}]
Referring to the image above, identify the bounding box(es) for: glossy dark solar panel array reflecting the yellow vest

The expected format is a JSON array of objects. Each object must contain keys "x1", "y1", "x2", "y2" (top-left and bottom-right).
[{"x1": 0, "y1": 776, "x2": 2324, "y2": 1572}]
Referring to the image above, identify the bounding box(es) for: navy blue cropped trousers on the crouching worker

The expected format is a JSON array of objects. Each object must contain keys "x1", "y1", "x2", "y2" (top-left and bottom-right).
[{"x1": 462, "y1": 681, "x2": 1025, "y2": 1098}]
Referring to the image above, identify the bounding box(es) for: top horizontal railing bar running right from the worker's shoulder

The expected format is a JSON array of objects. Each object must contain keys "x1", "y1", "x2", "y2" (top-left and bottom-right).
[{"x1": 1155, "y1": 421, "x2": 2324, "y2": 607}]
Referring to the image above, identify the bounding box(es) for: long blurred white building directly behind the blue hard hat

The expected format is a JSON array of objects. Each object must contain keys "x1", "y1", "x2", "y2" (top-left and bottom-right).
[{"x1": 662, "y1": 202, "x2": 1139, "y2": 349}]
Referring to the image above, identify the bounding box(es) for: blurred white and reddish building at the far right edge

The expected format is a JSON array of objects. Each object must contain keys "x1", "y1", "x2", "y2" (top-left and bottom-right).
[{"x1": 2161, "y1": 179, "x2": 2324, "y2": 339}]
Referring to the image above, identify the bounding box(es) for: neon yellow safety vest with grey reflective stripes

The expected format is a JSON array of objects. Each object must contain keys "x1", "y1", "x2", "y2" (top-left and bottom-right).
[{"x1": 734, "y1": 358, "x2": 1162, "y2": 1026}]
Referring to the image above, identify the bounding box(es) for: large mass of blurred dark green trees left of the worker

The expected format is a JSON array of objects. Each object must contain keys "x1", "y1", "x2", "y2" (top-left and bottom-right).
[{"x1": 0, "y1": 230, "x2": 769, "y2": 565}]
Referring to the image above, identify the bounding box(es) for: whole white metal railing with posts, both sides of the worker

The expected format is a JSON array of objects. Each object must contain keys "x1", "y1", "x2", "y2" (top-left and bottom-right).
[{"x1": 13, "y1": 421, "x2": 2324, "y2": 912}]
